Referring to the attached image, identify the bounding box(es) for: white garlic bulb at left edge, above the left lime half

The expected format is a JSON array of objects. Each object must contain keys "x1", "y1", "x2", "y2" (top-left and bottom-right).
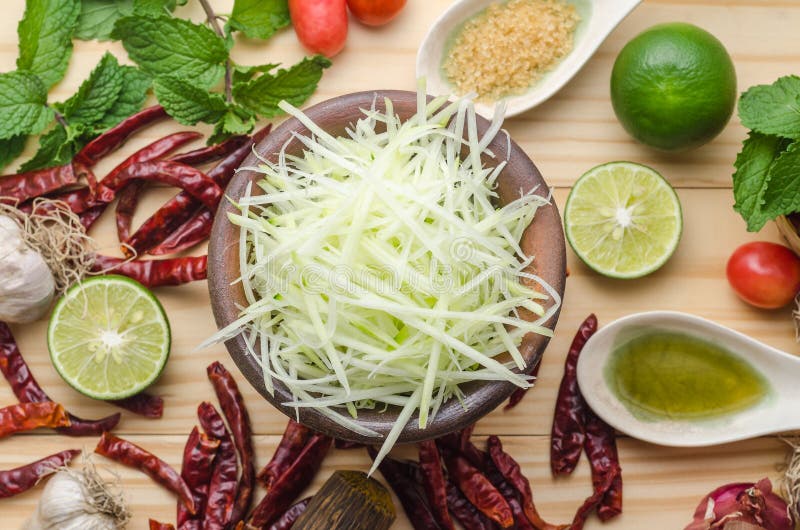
[{"x1": 0, "y1": 216, "x2": 55, "y2": 323}]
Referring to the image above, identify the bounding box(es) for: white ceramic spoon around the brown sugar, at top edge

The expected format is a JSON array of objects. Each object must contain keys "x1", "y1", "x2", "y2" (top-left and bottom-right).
[{"x1": 417, "y1": 0, "x2": 642, "y2": 118}]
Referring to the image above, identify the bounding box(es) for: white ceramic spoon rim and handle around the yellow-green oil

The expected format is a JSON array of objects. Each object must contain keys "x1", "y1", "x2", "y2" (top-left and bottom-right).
[{"x1": 578, "y1": 311, "x2": 800, "y2": 447}]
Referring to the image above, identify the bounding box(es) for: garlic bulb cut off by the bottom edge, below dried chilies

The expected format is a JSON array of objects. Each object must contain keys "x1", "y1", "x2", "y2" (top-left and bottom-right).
[{"x1": 23, "y1": 464, "x2": 130, "y2": 530}]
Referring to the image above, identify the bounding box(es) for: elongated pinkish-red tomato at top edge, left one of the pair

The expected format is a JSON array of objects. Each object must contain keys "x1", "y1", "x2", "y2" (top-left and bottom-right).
[{"x1": 289, "y1": 0, "x2": 347, "y2": 57}]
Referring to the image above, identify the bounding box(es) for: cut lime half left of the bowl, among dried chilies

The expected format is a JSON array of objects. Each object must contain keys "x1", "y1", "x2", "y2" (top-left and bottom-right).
[{"x1": 47, "y1": 275, "x2": 170, "y2": 399}]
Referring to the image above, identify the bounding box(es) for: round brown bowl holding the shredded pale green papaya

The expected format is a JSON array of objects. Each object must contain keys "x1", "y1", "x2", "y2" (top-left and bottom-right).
[{"x1": 208, "y1": 90, "x2": 566, "y2": 443}]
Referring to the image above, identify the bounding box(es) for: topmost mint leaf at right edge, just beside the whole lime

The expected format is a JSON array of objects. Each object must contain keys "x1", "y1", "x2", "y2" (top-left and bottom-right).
[{"x1": 739, "y1": 75, "x2": 800, "y2": 139}]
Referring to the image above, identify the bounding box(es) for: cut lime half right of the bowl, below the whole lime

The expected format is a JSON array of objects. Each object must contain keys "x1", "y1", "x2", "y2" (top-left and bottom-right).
[{"x1": 564, "y1": 162, "x2": 683, "y2": 278}]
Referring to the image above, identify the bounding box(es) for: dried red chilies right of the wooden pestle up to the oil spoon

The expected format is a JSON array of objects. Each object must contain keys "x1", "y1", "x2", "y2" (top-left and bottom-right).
[{"x1": 370, "y1": 315, "x2": 622, "y2": 530}]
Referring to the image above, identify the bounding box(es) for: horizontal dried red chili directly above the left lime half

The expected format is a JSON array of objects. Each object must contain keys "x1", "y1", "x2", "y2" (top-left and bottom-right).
[{"x1": 92, "y1": 254, "x2": 208, "y2": 287}]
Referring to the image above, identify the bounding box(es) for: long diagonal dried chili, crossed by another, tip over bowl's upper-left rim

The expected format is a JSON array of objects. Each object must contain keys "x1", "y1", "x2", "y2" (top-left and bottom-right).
[{"x1": 127, "y1": 125, "x2": 272, "y2": 253}]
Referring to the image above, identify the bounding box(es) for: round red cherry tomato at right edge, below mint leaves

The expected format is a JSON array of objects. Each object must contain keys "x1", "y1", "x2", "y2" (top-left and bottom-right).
[{"x1": 727, "y1": 241, "x2": 800, "y2": 309}]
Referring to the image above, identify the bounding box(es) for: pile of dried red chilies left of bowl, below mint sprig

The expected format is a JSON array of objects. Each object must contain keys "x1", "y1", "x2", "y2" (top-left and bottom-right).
[{"x1": 0, "y1": 106, "x2": 270, "y2": 287}]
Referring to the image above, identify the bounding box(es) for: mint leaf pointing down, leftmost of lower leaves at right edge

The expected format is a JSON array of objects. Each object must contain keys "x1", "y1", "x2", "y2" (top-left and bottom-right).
[{"x1": 733, "y1": 132, "x2": 788, "y2": 232}]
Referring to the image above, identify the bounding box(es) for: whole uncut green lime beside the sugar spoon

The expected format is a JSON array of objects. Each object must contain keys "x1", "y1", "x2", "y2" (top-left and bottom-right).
[{"x1": 611, "y1": 22, "x2": 736, "y2": 151}]
